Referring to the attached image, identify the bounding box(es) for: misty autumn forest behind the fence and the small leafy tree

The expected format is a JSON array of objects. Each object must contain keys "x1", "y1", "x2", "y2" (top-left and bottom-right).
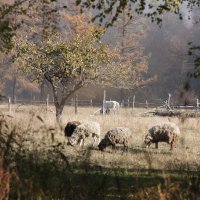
[{"x1": 0, "y1": 0, "x2": 200, "y2": 106}]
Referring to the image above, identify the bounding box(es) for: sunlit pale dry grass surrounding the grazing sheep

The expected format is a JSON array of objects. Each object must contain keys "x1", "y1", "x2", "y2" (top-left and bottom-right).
[{"x1": 1, "y1": 105, "x2": 200, "y2": 170}]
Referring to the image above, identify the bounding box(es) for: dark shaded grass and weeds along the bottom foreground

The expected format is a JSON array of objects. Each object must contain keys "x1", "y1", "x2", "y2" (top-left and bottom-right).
[{"x1": 6, "y1": 150, "x2": 200, "y2": 200}]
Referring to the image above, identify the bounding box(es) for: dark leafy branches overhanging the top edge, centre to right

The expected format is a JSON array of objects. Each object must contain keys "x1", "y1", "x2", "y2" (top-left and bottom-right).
[{"x1": 76, "y1": 0, "x2": 200, "y2": 27}]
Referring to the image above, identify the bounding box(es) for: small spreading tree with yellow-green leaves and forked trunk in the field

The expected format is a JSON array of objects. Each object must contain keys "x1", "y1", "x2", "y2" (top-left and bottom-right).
[{"x1": 12, "y1": 28, "x2": 115, "y2": 120}]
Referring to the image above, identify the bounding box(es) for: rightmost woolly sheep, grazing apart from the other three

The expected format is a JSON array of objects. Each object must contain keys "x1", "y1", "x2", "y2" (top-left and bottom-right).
[{"x1": 144, "y1": 122, "x2": 180, "y2": 150}]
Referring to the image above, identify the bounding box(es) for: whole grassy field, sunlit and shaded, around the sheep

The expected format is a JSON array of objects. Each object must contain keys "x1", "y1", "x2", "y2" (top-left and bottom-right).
[{"x1": 0, "y1": 105, "x2": 200, "y2": 199}]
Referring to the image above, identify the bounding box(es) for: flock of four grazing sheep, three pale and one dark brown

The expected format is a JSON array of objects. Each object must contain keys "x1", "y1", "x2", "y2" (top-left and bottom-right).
[{"x1": 64, "y1": 121, "x2": 180, "y2": 151}]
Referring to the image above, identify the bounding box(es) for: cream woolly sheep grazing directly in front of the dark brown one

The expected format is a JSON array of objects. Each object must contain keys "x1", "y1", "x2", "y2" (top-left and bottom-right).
[{"x1": 69, "y1": 122, "x2": 100, "y2": 146}]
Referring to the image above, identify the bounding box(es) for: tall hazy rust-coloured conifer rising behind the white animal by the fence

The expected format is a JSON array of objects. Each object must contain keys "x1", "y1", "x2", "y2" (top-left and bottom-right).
[{"x1": 104, "y1": 10, "x2": 155, "y2": 101}]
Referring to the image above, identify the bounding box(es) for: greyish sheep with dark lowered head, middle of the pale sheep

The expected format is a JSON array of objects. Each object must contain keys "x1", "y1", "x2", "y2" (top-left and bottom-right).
[{"x1": 98, "y1": 127, "x2": 132, "y2": 151}]
